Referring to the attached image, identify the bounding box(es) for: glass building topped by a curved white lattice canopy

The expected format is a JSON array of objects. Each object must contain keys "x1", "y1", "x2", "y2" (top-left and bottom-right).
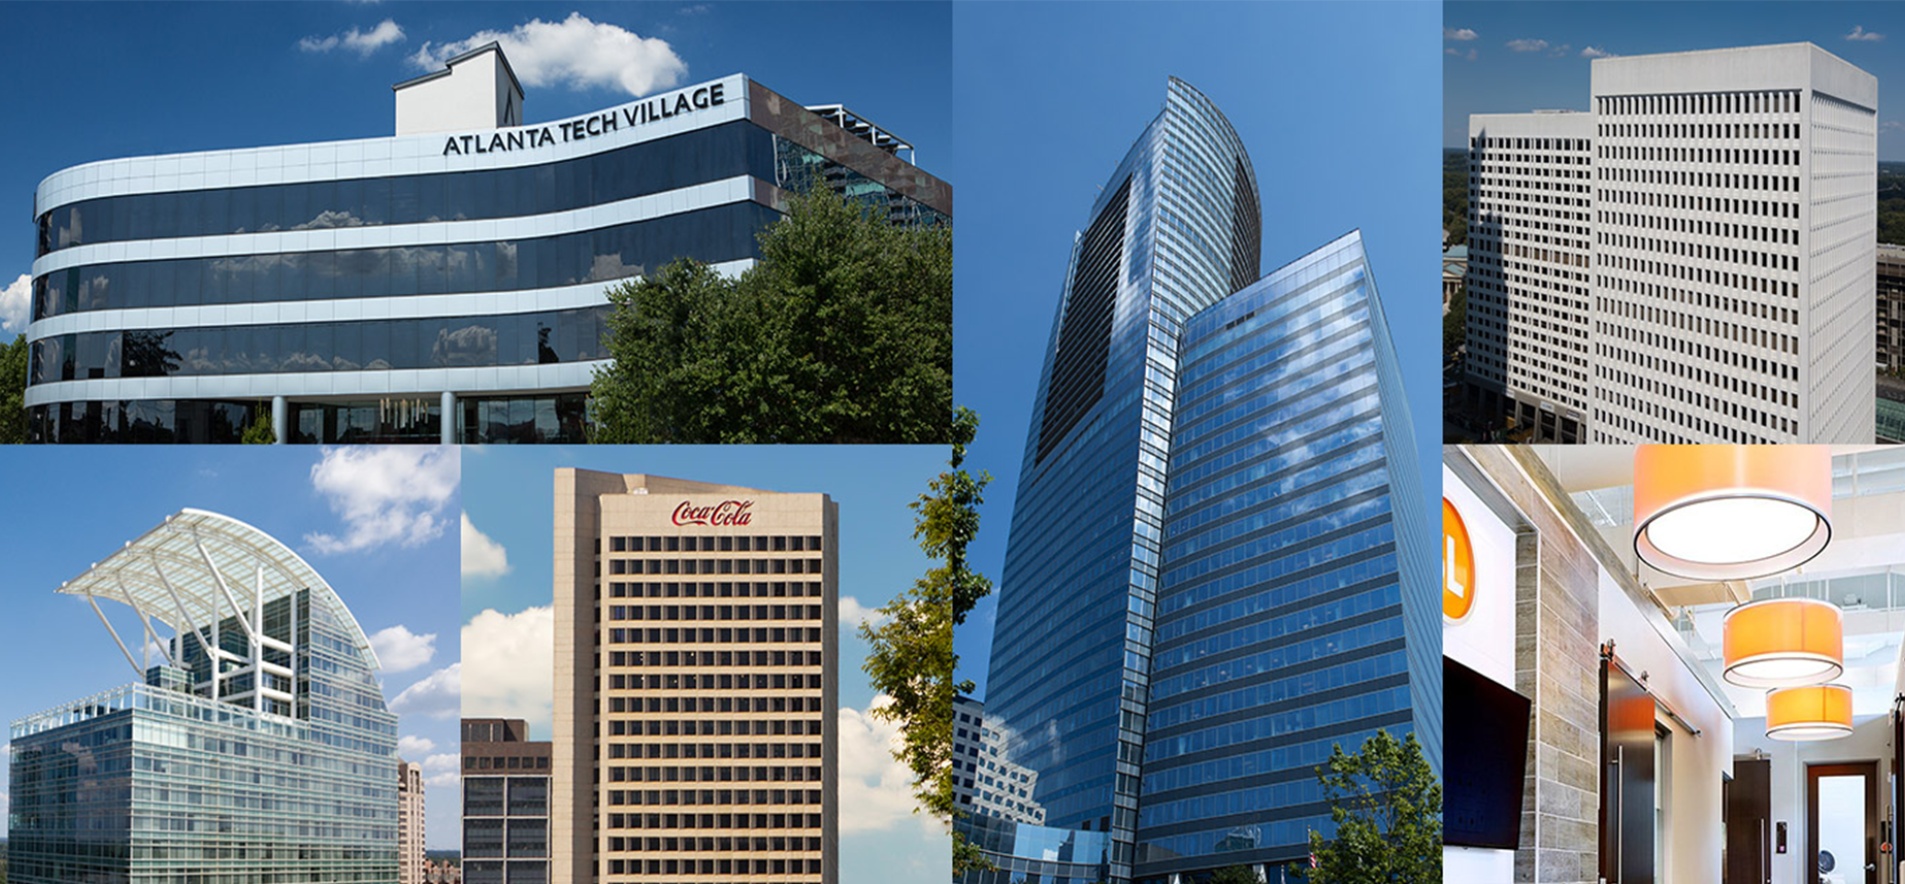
[{"x1": 8, "y1": 509, "x2": 398, "y2": 884}]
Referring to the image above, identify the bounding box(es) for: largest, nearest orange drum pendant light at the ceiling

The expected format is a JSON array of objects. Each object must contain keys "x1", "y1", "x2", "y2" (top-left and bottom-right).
[{"x1": 1634, "y1": 446, "x2": 1833, "y2": 581}]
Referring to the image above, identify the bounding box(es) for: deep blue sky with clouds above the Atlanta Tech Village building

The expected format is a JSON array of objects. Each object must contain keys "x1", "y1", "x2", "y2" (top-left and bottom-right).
[{"x1": 0, "y1": 2, "x2": 953, "y2": 337}]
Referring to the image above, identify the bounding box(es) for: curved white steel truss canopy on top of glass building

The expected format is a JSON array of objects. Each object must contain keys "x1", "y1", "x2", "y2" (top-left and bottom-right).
[{"x1": 59, "y1": 509, "x2": 377, "y2": 669}]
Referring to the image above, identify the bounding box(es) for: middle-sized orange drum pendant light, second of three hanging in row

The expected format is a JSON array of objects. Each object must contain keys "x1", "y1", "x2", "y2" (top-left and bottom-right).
[{"x1": 1726, "y1": 598, "x2": 1846, "y2": 688}]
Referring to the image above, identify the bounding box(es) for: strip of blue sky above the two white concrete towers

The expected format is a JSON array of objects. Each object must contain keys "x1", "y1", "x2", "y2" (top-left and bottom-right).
[{"x1": 1442, "y1": 2, "x2": 1905, "y2": 160}]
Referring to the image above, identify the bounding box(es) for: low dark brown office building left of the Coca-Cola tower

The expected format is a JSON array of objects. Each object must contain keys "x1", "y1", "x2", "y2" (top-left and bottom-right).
[{"x1": 463, "y1": 718, "x2": 551, "y2": 884}]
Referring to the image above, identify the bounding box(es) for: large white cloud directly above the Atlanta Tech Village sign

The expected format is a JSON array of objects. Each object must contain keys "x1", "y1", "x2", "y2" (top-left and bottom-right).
[{"x1": 410, "y1": 11, "x2": 688, "y2": 95}]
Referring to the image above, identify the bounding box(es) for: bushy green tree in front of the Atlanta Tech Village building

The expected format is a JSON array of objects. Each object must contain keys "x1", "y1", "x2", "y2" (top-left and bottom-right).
[{"x1": 592, "y1": 191, "x2": 953, "y2": 444}]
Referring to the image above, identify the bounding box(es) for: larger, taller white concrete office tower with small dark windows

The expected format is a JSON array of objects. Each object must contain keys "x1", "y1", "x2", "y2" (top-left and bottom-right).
[{"x1": 1591, "y1": 44, "x2": 1878, "y2": 442}]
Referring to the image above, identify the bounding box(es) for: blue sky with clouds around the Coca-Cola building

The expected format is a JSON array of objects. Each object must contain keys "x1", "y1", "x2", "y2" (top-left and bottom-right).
[{"x1": 463, "y1": 446, "x2": 951, "y2": 884}]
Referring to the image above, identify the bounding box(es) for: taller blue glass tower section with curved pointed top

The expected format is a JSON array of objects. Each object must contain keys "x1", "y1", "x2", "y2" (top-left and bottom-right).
[{"x1": 985, "y1": 78, "x2": 1261, "y2": 880}]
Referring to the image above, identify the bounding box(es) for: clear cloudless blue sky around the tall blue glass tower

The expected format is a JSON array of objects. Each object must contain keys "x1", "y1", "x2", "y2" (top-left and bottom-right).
[{"x1": 945, "y1": 4, "x2": 1442, "y2": 697}]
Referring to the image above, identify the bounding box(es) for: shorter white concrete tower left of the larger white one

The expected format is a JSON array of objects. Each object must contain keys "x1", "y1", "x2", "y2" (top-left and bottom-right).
[{"x1": 1467, "y1": 111, "x2": 1594, "y2": 442}]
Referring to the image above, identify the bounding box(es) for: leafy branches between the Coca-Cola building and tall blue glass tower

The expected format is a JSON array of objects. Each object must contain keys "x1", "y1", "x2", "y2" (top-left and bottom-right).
[{"x1": 859, "y1": 408, "x2": 993, "y2": 874}]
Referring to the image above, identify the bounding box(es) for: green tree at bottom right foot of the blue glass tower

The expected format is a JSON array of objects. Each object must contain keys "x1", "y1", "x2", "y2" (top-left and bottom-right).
[{"x1": 1290, "y1": 730, "x2": 1442, "y2": 884}]
